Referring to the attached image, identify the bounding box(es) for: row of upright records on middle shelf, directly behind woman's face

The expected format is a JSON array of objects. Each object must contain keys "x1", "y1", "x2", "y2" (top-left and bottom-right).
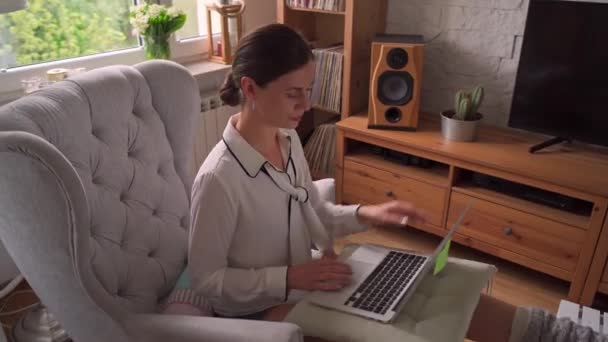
[{"x1": 311, "y1": 45, "x2": 344, "y2": 113}]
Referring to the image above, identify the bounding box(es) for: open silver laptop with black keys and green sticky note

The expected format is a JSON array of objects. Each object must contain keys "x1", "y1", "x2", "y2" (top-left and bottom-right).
[{"x1": 307, "y1": 203, "x2": 472, "y2": 323}]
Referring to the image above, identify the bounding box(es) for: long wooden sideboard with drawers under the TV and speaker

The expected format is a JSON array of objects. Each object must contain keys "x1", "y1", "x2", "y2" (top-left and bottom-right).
[{"x1": 336, "y1": 114, "x2": 608, "y2": 305}]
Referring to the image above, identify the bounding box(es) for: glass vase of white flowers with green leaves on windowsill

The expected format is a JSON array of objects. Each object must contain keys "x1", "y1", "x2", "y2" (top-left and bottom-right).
[{"x1": 130, "y1": 3, "x2": 186, "y2": 59}]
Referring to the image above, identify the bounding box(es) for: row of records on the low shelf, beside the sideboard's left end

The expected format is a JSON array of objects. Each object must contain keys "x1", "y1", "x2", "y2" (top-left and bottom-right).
[{"x1": 304, "y1": 123, "x2": 336, "y2": 178}]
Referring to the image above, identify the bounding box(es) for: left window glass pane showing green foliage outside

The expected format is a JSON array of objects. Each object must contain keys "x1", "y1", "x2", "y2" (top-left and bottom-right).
[{"x1": 0, "y1": 0, "x2": 139, "y2": 69}]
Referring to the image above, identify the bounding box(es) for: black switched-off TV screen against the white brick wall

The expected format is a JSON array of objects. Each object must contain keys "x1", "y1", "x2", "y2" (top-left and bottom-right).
[{"x1": 509, "y1": 0, "x2": 608, "y2": 146}]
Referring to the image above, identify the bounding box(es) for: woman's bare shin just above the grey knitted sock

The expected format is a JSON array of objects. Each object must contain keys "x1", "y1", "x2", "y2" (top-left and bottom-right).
[{"x1": 467, "y1": 294, "x2": 517, "y2": 342}]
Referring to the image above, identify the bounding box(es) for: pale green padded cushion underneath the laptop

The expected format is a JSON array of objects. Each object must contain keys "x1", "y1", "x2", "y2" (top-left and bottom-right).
[{"x1": 285, "y1": 247, "x2": 496, "y2": 342}]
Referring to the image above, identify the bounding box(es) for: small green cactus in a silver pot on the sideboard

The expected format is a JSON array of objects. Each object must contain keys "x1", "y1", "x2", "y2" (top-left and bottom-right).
[{"x1": 441, "y1": 86, "x2": 484, "y2": 141}]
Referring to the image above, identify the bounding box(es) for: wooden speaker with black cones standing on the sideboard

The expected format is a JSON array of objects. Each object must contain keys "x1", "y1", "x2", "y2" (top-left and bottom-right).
[{"x1": 368, "y1": 34, "x2": 424, "y2": 131}]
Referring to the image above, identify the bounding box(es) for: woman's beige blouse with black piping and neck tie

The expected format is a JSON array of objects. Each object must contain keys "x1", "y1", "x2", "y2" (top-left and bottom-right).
[{"x1": 188, "y1": 114, "x2": 366, "y2": 316}]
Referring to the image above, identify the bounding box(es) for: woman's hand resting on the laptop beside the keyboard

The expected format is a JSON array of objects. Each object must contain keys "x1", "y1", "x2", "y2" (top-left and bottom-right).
[{"x1": 287, "y1": 258, "x2": 353, "y2": 291}]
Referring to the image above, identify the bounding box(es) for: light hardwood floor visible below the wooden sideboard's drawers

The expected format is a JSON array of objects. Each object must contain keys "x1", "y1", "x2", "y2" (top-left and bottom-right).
[{"x1": 336, "y1": 228, "x2": 569, "y2": 313}]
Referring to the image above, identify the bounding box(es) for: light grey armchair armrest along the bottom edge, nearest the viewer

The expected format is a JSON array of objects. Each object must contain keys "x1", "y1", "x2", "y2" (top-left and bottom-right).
[{"x1": 123, "y1": 314, "x2": 303, "y2": 342}]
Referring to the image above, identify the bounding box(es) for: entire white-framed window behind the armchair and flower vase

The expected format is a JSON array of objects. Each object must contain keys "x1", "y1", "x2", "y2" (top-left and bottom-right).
[{"x1": 0, "y1": 0, "x2": 230, "y2": 72}]
